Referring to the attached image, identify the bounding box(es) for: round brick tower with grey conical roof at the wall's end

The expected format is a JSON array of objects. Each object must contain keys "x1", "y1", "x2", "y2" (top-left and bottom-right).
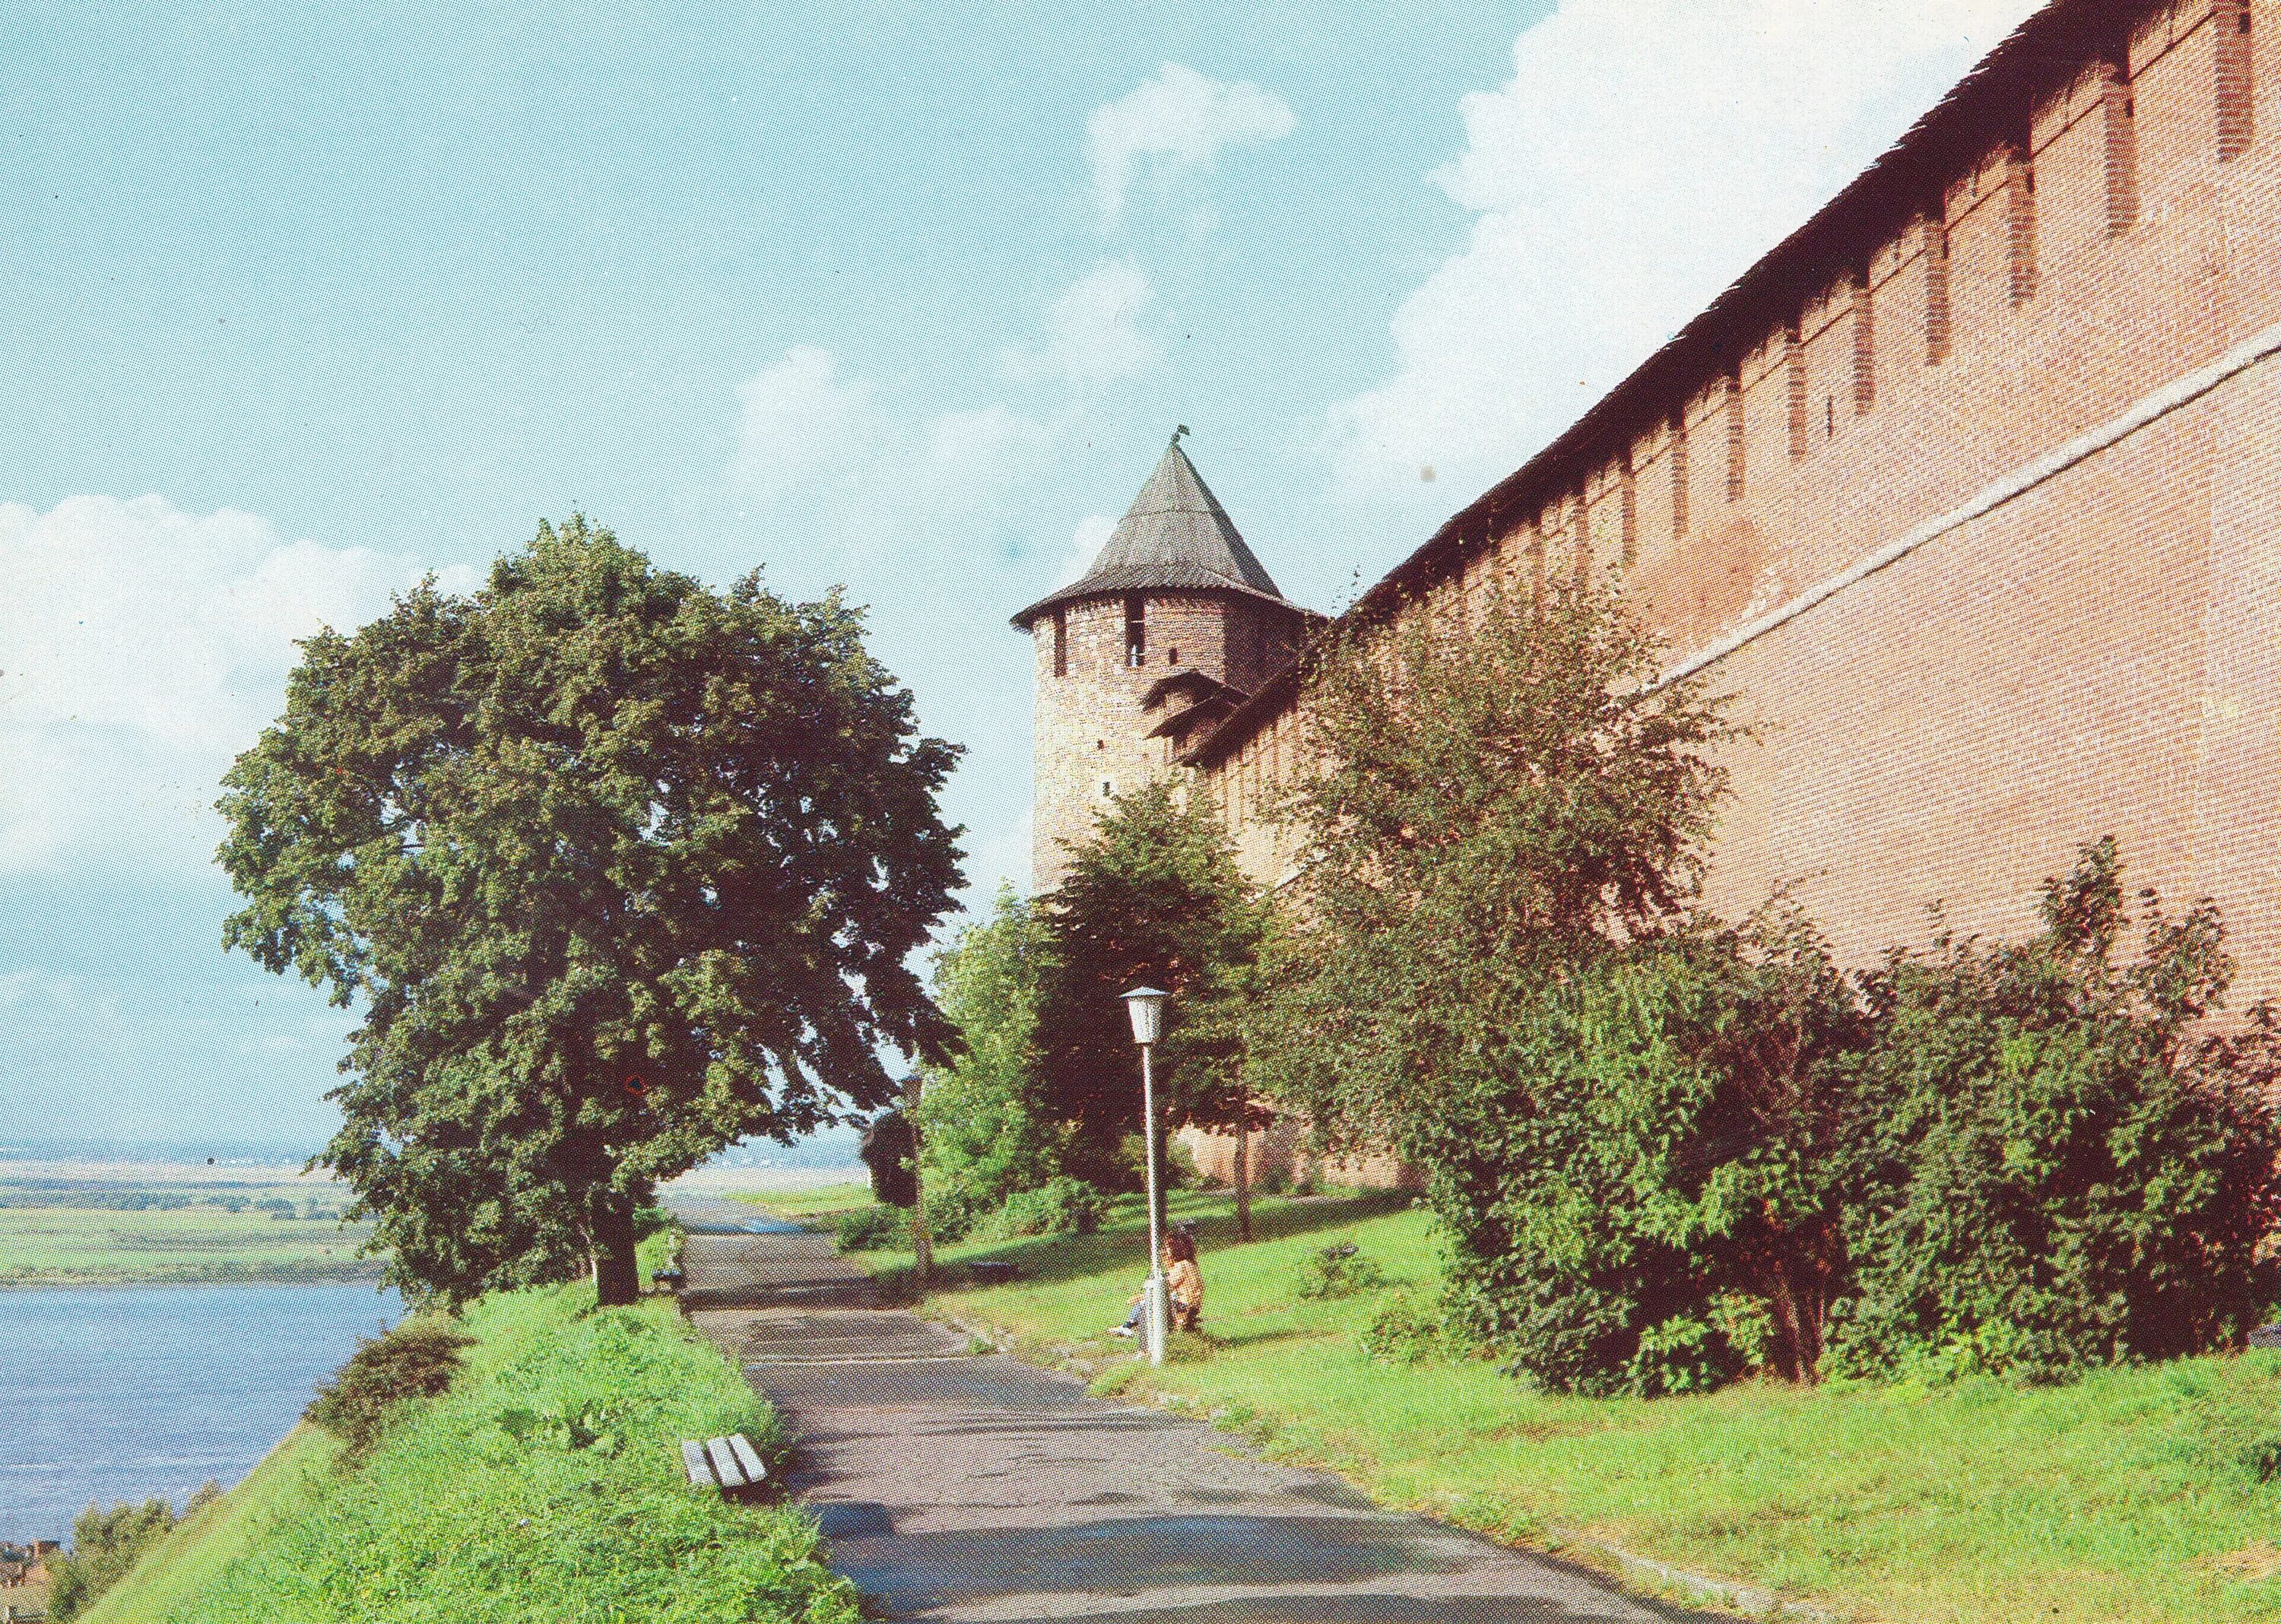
[{"x1": 1013, "y1": 431, "x2": 1321, "y2": 894}]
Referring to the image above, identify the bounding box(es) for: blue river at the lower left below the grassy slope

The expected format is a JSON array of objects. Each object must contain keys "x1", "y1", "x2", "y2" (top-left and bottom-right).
[{"x1": 0, "y1": 1284, "x2": 404, "y2": 1542}]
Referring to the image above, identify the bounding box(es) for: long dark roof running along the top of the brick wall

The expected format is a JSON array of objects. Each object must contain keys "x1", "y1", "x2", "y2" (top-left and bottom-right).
[{"x1": 1182, "y1": 0, "x2": 2167, "y2": 766}]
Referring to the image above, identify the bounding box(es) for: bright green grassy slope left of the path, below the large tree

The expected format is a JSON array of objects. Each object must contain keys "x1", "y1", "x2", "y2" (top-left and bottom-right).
[{"x1": 89, "y1": 1286, "x2": 855, "y2": 1624}]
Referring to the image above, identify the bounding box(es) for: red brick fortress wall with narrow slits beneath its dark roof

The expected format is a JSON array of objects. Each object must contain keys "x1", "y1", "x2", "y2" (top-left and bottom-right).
[{"x1": 1204, "y1": 0, "x2": 2281, "y2": 1004}]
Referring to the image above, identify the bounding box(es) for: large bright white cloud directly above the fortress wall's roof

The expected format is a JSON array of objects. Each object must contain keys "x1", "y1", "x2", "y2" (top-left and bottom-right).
[{"x1": 1332, "y1": 0, "x2": 2037, "y2": 495}]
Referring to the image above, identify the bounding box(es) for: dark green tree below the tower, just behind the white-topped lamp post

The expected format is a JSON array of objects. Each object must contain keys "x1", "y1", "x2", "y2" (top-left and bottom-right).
[{"x1": 1038, "y1": 782, "x2": 1268, "y2": 1223}]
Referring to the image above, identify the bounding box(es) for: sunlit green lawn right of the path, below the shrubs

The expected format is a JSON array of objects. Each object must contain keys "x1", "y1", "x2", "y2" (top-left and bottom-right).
[{"x1": 762, "y1": 1186, "x2": 2281, "y2": 1624}]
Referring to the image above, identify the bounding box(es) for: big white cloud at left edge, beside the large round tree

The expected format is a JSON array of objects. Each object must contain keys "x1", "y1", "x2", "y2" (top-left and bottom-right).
[{"x1": 0, "y1": 497, "x2": 458, "y2": 874}]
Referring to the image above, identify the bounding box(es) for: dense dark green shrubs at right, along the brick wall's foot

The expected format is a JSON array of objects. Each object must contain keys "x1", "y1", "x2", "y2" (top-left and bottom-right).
[{"x1": 1398, "y1": 842, "x2": 2281, "y2": 1394}]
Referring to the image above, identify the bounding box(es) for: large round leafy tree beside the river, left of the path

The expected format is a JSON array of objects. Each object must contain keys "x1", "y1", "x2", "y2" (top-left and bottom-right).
[{"x1": 219, "y1": 518, "x2": 958, "y2": 1302}]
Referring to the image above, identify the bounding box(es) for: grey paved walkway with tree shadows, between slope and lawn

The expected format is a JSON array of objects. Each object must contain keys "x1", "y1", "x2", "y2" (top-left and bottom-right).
[{"x1": 675, "y1": 1197, "x2": 1706, "y2": 1624}]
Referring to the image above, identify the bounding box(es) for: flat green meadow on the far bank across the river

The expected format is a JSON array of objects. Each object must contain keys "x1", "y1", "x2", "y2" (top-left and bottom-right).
[{"x1": 0, "y1": 1175, "x2": 381, "y2": 1286}]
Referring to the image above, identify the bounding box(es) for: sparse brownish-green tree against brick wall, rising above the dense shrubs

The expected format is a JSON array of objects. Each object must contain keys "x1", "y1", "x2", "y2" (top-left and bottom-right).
[{"x1": 1250, "y1": 584, "x2": 1738, "y2": 1161}]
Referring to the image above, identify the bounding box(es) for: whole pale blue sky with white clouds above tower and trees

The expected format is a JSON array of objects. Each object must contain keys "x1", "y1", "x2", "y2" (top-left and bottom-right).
[{"x1": 0, "y1": 0, "x2": 2037, "y2": 1154}]
